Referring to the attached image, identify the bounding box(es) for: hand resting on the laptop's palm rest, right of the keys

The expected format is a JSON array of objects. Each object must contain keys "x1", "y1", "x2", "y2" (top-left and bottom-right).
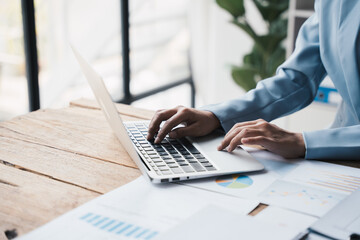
[{"x1": 218, "y1": 119, "x2": 305, "y2": 158}]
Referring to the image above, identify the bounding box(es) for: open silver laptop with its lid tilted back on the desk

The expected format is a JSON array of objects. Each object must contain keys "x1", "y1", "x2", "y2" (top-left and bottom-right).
[{"x1": 72, "y1": 47, "x2": 264, "y2": 183}]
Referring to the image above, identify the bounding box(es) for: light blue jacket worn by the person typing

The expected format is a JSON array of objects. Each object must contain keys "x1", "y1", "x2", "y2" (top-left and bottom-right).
[{"x1": 205, "y1": 0, "x2": 360, "y2": 159}]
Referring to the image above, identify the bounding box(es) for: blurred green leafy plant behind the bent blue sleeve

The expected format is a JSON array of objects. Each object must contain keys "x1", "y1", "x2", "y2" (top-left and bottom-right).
[{"x1": 216, "y1": 0, "x2": 289, "y2": 91}]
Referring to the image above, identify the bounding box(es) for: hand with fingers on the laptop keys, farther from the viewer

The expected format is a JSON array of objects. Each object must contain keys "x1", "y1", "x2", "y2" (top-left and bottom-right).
[{"x1": 147, "y1": 106, "x2": 220, "y2": 143}]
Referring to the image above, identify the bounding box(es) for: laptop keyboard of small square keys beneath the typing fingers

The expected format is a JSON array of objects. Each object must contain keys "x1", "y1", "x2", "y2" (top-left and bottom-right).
[{"x1": 125, "y1": 123, "x2": 216, "y2": 175}]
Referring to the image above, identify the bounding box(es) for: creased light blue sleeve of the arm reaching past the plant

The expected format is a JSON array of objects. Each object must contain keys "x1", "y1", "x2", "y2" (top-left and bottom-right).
[{"x1": 202, "y1": 5, "x2": 326, "y2": 132}]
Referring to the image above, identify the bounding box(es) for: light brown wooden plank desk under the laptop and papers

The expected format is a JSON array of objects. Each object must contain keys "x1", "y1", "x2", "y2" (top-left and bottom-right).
[{"x1": 0, "y1": 99, "x2": 360, "y2": 239}]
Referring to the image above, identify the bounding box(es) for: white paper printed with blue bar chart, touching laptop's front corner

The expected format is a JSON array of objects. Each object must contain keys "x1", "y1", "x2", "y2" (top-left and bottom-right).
[{"x1": 20, "y1": 177, "x2": 258, "y2": 240}]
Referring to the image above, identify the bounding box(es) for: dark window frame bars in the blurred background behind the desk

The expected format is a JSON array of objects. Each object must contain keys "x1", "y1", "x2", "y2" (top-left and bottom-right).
[{"x1": 21, "y1": 0, "x2": 196, "y2": 111}]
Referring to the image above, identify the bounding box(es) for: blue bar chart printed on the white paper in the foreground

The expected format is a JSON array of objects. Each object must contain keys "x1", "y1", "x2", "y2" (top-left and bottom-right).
[{"x1": 79, "y1": 212, "x2": 158, "y2": 240}]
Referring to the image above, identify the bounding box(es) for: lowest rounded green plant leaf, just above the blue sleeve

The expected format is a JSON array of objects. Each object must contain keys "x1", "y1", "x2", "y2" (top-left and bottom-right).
[{"x1": 231, "y1": 66, "x2": 258, "y2": 91}]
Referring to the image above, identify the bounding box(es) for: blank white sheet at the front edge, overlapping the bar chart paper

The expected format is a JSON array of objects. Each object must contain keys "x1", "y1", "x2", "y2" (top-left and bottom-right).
[{"x1": 157, "y1": 206, "x2": 298, "y2": 240}]
